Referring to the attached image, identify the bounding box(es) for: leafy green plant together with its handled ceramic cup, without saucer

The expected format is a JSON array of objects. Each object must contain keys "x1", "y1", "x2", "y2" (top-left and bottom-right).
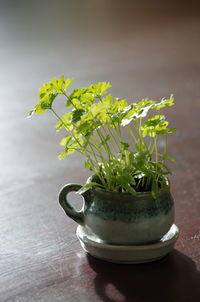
[{"x1": 29, "y1": 76, "x2": 178, "y2": 264}]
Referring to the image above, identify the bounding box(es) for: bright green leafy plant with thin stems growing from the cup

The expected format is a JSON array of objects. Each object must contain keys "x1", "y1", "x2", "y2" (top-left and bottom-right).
[{"x1": 29, "y1": 76, "x2": 175, "y2": 197}]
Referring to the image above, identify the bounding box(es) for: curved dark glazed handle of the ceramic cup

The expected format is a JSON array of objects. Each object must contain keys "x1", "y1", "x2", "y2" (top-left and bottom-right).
[{"x1": 59, "y1": 184, "x2": 84, "y2": 225}]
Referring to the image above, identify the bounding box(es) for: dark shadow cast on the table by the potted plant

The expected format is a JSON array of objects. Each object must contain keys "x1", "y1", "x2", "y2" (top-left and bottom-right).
[{"x1": 88, "y1": 250, "x2": 200, "y2": 302}]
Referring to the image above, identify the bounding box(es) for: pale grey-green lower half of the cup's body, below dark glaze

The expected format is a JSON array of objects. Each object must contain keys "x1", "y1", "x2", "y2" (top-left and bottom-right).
[{"x1": 85, "y1": 206, "x2": 174, "y2": 245}]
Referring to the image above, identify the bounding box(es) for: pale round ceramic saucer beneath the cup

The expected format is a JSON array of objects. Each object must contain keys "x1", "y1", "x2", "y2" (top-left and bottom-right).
[{"x1": 76, "y1": 224, "x2": 179, "y2": 264}]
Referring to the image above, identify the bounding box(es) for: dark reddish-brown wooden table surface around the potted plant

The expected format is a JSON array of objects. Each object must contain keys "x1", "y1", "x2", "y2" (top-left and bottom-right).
[{"x1": 0, "y1": 0, "x2": 200, "y2": 302}]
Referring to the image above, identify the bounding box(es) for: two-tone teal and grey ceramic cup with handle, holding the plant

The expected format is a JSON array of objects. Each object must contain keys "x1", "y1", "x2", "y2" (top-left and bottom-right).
[{"x1": 59, "y1": 180, "x2": 174, "y2": 245}]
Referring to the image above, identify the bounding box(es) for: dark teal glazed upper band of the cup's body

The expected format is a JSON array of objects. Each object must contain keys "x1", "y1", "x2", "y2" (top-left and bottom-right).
[{"x1": 85, "y1": 190, "x2": 173, "y2": 223}]
